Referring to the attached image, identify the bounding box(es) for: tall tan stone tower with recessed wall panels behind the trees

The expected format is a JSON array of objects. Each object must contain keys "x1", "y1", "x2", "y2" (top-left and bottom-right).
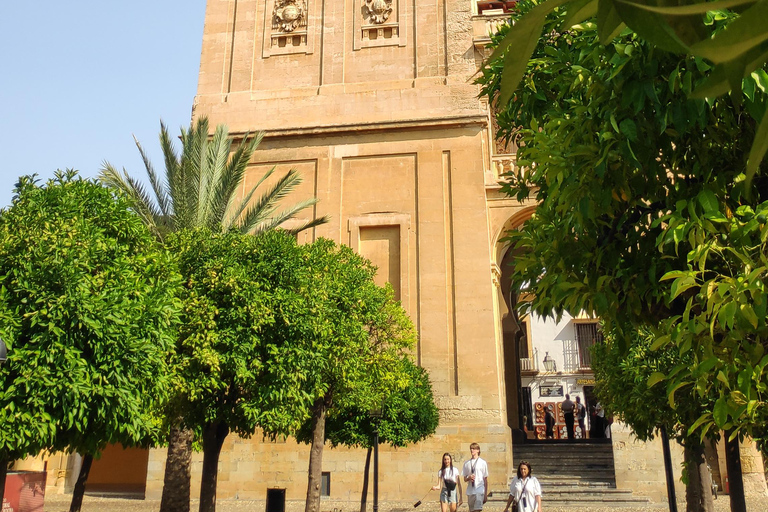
[{"x1": 147, "y1": 0, "x2": 512, "y2": 503}]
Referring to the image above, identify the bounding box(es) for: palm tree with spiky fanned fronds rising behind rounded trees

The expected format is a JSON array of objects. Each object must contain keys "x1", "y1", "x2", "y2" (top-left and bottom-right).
[{"x1": 99, "y1": 117, "x2": 328, "y2": 512}]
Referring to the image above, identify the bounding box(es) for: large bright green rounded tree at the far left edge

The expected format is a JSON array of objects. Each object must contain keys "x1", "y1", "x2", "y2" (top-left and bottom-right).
[{"x1": 0, "y1": 171, "x2": 180, "y2": 511}]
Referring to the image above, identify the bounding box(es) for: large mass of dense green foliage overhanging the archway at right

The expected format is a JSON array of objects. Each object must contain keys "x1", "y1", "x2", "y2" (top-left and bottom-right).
[{"x1": 481, "y1": 3, "x2": 768, "y2": 446}]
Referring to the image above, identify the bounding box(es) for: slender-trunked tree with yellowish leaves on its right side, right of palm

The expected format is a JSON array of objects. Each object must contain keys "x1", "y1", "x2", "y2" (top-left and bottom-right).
[{"x1": 275, "y1": 239, "x2": 416, "y2": 512}]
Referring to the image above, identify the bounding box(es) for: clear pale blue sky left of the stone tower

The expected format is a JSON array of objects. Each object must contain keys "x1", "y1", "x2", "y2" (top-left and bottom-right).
[{"x1": 0, "y1": 0, "x2": 205, "y2": 207}]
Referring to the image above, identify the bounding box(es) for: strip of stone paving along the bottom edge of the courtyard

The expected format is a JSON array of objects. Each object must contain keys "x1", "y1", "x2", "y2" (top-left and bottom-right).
[{"x1": 45, "y1": 494, "x2": 765, "y2": 512}]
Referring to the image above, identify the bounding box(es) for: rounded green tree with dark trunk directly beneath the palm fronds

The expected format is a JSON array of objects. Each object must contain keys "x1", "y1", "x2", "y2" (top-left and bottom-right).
[{"x1": 167, "y1": 229, "x2": 309, "y2": 512}]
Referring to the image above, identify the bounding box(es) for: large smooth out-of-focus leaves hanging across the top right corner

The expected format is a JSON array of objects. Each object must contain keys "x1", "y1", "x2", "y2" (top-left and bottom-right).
[{"x1": 489, "y1": 0, "x2": 768, "y2": 182}]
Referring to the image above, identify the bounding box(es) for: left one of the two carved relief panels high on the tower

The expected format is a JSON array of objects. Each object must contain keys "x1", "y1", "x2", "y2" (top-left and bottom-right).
[{"x1": 262, "y1": 0, "x2": 319, "y2": 58}]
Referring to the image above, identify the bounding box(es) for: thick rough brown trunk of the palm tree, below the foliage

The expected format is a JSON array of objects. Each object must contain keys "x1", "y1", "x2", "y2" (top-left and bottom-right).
[{"x1": 160, "y1": 422, "x2": 195, "y2": 512}]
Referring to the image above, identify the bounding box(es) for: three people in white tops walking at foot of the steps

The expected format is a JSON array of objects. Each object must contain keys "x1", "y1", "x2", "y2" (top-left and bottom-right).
[{"x1": 432, "y1": 443, "x2": 541, "y2": 512}]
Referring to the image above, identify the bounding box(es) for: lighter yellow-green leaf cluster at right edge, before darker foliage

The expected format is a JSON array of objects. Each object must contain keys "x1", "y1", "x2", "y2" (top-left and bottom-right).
[{"x1": 654, "y1": 198, "x2": 768, "y2": 442}]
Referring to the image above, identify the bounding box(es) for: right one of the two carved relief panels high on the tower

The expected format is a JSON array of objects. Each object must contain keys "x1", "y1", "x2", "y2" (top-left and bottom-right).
[{"x1": 354, "y1": 0, "x2": 407, "y2": 50}]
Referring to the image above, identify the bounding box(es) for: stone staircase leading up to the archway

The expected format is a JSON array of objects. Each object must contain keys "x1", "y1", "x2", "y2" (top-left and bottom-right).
[{"x1": 491, "y1": 440, "x2": 649, "y2": 508}]
